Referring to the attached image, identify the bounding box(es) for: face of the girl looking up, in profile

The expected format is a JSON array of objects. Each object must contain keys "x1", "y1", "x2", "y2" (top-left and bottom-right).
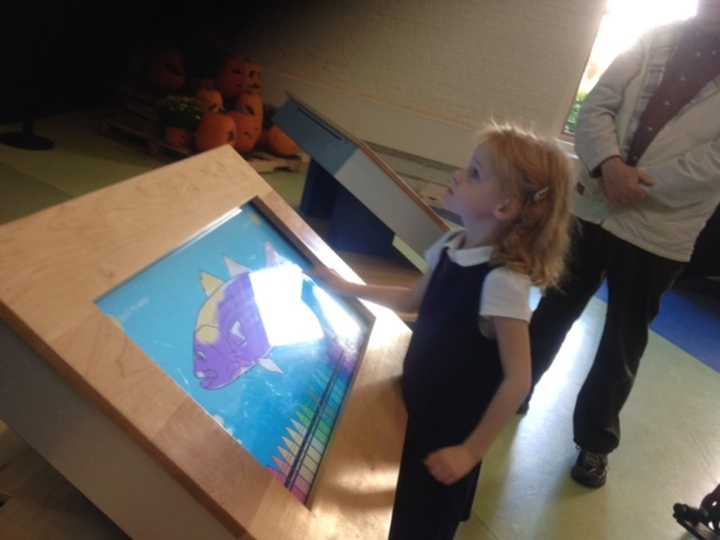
[{"x1": 443, "y1": 145, "x2": 508, "y2": 225}]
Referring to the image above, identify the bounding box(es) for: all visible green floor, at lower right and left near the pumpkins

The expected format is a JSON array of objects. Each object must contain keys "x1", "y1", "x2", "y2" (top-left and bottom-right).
[{"x1": 0, "y1": 113, "x2": 720, "y2": 540}]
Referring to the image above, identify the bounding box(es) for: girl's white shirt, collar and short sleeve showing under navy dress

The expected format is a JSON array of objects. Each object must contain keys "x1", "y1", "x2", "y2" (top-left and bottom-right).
[{"x1": 425, "y1": 230, "x2": 532, "y2": 337}]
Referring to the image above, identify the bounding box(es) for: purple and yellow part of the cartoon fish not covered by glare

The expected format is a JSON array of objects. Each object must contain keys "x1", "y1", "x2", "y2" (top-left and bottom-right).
[{"x1": 194, "y1": 244, "x2": 292, "y2": 390}]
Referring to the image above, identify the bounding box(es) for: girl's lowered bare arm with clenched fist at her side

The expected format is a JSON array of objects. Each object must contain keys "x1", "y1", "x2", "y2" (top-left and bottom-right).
[{"x1": 425, "y1": 317, "x2": 531, "y2": 485}]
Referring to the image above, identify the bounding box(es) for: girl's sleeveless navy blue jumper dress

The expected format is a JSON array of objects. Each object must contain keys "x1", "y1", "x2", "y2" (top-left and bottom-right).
[{"x1": 390, "y1": 248, "x2": 503, "y2": 540}]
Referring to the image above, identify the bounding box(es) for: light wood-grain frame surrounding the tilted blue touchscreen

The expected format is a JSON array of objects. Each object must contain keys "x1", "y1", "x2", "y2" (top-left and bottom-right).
[{"x1": 0, "y1": 146, "x2": 410, "y2": 539}]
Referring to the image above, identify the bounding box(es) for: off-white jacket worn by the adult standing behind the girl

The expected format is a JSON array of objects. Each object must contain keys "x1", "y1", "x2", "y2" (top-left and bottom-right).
[{"x1": 575, "y1": 23, "x2": 720, "y2": 261}]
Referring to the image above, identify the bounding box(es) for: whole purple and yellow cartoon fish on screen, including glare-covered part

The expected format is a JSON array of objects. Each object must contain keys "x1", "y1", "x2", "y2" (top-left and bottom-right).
[{"x1": 194, "y1": 243, "x2": 360, "y2": 390}]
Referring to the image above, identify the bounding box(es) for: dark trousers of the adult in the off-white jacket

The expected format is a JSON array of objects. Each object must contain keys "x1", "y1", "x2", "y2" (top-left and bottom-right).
[{"x1": 530, "y1": 220, "x2": 685, "y2": 453}]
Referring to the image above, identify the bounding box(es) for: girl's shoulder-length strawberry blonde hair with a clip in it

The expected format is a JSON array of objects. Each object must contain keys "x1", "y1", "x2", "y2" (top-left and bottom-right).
[{"x1": 478, "y1": 123, "x2": 573, "y2": 287}]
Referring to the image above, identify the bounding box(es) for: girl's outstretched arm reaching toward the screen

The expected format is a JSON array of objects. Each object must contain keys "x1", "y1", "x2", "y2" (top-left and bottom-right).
[{"x1": 312, "y1": 267, "x2": 431, "y2": 313}]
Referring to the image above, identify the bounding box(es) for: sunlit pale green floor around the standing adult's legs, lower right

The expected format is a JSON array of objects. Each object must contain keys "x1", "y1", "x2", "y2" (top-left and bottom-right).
[{"x1": 457, "y1": 299, "x2": 720, "y2": 540}]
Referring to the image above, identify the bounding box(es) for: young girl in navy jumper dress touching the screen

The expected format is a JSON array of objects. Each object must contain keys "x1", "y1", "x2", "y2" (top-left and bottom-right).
[{"x1": 316, "y1": 125, "x2": 570, "y2": 540}]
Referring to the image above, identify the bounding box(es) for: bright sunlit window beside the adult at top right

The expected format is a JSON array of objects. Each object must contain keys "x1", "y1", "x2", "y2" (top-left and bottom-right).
[{"x1": 563, "y1": 0, "x2": 697, "y2": 135}]
